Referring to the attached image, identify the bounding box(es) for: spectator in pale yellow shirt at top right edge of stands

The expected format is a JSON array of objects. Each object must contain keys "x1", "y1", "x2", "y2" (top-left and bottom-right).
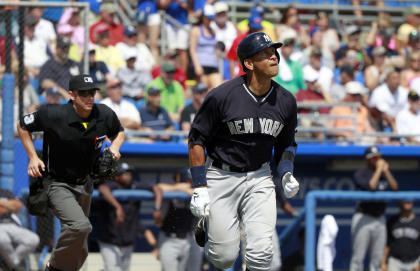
[{"x1": 397, "y1": 5, "x2": 420, "y2": 49}]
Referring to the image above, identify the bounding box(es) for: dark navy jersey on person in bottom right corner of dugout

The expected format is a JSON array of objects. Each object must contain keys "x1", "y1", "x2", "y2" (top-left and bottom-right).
[{"x1": 387, "y1": 215, "x2": 420, "y2": 262}]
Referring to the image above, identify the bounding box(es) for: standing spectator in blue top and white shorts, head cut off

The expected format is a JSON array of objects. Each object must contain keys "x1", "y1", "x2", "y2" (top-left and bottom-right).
[{"x1": 157, "y1": 0, "x2": 190, "y2": 72}]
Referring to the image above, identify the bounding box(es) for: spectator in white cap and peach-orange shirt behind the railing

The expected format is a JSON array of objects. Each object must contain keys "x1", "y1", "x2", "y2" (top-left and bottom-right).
[{"x1": 329, "y1": 81, "x2": 374, "y2": 140}]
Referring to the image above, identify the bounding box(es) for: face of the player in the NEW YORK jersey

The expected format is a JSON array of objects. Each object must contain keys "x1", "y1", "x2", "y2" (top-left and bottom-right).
[{"x1": 252, "y1": 47, "x2": 279, "y2": 77}]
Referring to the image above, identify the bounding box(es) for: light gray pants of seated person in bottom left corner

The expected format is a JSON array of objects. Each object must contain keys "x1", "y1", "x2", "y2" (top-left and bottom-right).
[{"x1": 0, "y1": 223, "x2": 39, "y2": 269}]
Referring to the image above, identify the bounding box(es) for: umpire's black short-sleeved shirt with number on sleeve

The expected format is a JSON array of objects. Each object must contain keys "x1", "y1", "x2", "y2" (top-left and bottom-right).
[{"x1": 20, "y1": 101, "x2": 123, "y2": 182}]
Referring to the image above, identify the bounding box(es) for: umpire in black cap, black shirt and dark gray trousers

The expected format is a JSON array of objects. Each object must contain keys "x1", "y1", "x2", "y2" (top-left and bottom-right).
[{"x1": 17, "y1": 74, "x2": 125, "y2": 271}]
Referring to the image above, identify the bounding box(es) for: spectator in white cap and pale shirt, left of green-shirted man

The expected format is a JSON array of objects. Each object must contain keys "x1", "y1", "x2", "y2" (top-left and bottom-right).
[{"x1": 117, "y1": 48, "x2": 152, "y2": 101}]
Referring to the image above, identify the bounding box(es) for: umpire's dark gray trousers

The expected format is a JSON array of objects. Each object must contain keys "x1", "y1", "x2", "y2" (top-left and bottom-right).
[{"x1": 48, "y1": 180, "x2": 93, "y2": 271}]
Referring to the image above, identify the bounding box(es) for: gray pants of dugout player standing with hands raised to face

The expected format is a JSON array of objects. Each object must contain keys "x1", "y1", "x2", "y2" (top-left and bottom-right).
[{"x1": 350, "y1": 213, "x2": 386, "y2": 271}]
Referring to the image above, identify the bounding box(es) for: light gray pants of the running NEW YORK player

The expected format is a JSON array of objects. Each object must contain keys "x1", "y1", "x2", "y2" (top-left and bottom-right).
[{"x1": 204, "y1": 163, "x2": 277, "y2": 271}]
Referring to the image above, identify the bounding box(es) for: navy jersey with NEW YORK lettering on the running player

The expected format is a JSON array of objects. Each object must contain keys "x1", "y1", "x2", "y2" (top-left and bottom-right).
[{"x1": 189, "y1": 75, "x2": 297, "y2": 168}]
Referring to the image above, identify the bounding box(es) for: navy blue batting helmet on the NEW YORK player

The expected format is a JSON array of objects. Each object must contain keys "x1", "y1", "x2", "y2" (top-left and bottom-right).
[{"x1": 236, "y1": 32, "x2": 283, "y2": 71}]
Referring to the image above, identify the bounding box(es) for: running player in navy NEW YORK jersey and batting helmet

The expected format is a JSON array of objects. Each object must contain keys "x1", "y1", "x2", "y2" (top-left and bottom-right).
[{"x1": 188, "y1": 32, "x2": 299, "y2": 271}]
